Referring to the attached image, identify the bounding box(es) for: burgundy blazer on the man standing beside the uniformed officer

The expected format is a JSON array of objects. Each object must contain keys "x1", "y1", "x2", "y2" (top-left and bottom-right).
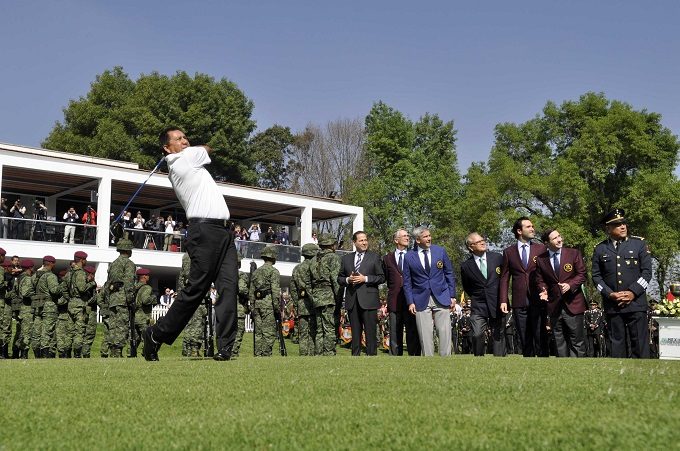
[{"x1": 536, "y1": 247, "x2": 587, "y2": 315}]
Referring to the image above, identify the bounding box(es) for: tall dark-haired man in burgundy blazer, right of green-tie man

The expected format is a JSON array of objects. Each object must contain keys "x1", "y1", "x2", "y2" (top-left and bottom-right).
[{"x1": 500, "y1": 216, "x2": 547, "y2": 357}]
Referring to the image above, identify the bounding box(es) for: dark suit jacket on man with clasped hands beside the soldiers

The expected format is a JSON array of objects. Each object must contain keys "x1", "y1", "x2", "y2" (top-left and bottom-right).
[{"x1": 338, "y1": 251, "x2": 385, "y2": 310}]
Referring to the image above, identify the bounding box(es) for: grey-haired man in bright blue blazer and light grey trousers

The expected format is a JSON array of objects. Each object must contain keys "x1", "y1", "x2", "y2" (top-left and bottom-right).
[{"x1": 404, "y1": 227, "x2": 456, "y2": 356}]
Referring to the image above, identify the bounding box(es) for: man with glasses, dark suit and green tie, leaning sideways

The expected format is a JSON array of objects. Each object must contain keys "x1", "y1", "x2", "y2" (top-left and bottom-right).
[{"x1": 460, "y1": 232, "x2": 505, "y2": 356}]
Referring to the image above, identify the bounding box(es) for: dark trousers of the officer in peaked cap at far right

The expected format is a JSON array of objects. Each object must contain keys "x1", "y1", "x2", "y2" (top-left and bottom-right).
[{"x1": 607, "y1": 312, "x2": 649, "y2": 359}]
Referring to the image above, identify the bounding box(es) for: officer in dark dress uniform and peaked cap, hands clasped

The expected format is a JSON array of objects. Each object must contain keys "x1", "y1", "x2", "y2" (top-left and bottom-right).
[{"x1": 592, "y1": 208, "x2": 652, "y2": 358}]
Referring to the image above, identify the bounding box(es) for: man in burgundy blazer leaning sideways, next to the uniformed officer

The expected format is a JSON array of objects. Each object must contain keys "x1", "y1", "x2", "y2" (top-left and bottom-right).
[{"x1": 536, "y1": 229, "x2": 586, "y2": 357}]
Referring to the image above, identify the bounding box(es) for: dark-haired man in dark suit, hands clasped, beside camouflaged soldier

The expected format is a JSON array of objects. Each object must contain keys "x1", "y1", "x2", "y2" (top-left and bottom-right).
[{"x1": 338, "y1": 231, "x2": 385, "y2": 356}]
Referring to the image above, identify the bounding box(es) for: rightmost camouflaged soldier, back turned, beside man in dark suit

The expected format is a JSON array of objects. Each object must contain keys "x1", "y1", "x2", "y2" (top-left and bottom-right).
[{"x1": 309, "y1": 233, "x2": 340, "y2": 355}]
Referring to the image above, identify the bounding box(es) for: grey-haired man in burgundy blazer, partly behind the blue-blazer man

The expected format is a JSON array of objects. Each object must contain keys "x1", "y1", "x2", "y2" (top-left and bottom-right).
[{"x1": 383, "y1": 229, "x2": 420, "y2": 356}]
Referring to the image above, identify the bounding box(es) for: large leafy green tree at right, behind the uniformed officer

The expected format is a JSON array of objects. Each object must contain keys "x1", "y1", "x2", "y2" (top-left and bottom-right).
[{"x1": 465, "y1": 93, "x2": 680, "y2": 296}]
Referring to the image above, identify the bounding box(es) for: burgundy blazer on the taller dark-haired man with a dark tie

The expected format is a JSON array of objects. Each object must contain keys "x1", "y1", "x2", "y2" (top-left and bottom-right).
[{"x1": 499, "y1": 241, "x2": 546, "y2": 308}]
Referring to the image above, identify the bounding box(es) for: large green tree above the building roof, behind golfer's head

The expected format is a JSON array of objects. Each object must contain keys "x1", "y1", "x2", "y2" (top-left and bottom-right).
[{"x1": 42, "y1": 67, "x2": 257, "y2": 184}]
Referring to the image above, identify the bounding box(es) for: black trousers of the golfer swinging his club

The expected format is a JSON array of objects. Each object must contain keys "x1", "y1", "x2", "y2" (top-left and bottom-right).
[{"x1": 152, "y1": 222, "x2": 238, "y2": 354}]
